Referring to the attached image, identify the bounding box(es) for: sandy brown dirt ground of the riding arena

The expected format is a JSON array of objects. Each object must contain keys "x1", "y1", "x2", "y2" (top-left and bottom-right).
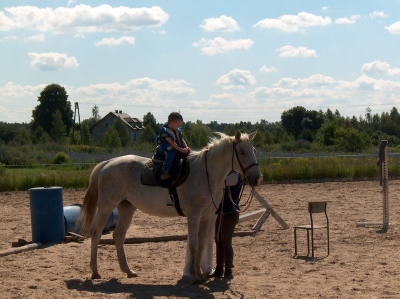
[{"x1": 0, "y1": 180, "x2": 400, "y2": 299}]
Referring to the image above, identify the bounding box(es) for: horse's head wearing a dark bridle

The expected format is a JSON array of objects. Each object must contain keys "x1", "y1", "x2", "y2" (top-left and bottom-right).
[{"x1": 232, "y1": 131, "x2": 263, "y2": 186}]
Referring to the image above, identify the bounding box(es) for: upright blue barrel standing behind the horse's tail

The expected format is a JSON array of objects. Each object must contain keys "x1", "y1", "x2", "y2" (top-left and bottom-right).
[{"x1": 29, "y1": 186, "x2": 64, "y2": 243}]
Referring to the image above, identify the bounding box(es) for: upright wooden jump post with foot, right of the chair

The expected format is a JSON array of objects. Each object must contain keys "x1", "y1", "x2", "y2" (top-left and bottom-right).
[{"x1": 357, "y1": 140, "x2": 390, "y2": 229}]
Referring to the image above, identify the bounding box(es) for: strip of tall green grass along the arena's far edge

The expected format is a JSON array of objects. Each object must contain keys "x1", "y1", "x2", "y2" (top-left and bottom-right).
[{"x1": 0, "y1": 156, "x2": 400, "y2": 192}]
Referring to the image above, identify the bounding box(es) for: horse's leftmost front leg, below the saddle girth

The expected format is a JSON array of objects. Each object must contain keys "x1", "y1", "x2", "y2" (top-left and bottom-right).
[{"x1": 188, "y1": 217, "x2": 202, "y2": 284}]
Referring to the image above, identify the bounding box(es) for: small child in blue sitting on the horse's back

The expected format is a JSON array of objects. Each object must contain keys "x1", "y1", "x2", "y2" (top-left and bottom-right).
[{"x1": 156, "y1": 112, "x2": 190, "y2": 180}]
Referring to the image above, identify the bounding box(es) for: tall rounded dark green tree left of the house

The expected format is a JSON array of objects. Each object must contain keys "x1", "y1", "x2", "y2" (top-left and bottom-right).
[{"x1": 31, "y1": 84, "x2": 74, "y2": 133}]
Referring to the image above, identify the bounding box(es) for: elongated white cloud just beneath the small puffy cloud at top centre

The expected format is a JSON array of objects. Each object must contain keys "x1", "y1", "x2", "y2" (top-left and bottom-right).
[{"x1": 193, "y1": 37, "x2": 254, "y2": 55}]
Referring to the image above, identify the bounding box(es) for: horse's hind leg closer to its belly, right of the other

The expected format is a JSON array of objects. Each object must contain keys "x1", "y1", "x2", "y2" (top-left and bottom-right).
[{"x1": 113, "y1": 200, "x2": 137, "y2": 277}]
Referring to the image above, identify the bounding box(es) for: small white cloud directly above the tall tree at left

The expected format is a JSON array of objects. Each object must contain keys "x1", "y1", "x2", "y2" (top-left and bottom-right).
[{"x1": 28, "y1": 52, "x2": 79, "y2": 71}]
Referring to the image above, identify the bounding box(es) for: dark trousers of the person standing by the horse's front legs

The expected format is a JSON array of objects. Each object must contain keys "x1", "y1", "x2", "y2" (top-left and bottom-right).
[{"x1": 215, "y1": 211, "x2": 239, "y2": 270}]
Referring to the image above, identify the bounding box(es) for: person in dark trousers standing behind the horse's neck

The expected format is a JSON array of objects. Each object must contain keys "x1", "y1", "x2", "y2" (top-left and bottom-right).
[{"x1": 208, "y1": 171, "x2": 243, "y2": 279}]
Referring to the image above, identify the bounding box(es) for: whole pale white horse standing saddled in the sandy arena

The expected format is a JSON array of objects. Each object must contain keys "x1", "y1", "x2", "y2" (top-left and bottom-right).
[{"x1": 77, "y1": 131, "x2": 262, "y2": 283}]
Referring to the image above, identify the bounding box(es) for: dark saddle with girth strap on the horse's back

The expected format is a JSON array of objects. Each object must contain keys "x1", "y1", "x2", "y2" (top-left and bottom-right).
[{"x1": 140, "y1": 155, "x2": 190, "y2": 216}]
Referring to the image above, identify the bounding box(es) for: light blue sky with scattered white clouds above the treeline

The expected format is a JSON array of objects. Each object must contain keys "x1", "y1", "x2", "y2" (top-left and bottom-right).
[{"x1": 0, "y1": 0, "x2": 400, "y2": 123}]
